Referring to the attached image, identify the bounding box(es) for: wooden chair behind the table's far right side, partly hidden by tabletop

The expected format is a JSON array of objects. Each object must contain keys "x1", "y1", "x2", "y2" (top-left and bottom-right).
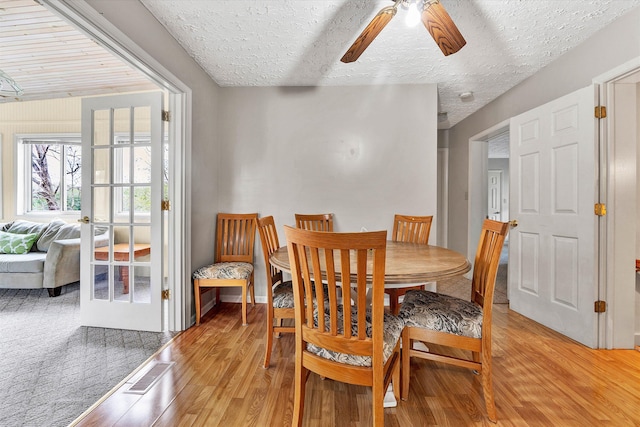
[{"x1": 385, "y1": 214, "x2": 433, "y2": 315}]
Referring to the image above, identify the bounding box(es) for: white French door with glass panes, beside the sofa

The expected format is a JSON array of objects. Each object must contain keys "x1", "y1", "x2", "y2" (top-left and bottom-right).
[{"x1": 80, "y1": 92, "x2": 164, "y2": 331}]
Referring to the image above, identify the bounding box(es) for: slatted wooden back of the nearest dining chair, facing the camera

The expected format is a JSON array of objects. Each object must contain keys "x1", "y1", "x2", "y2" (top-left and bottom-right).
[{"x1": 285, "y1": 226, "x2": 386, "y2": 363}]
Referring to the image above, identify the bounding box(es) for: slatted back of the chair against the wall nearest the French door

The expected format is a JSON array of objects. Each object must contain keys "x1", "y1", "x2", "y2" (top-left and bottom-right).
[{"x1": 215, "y1": 213, "x2": 258, "y2": 263}]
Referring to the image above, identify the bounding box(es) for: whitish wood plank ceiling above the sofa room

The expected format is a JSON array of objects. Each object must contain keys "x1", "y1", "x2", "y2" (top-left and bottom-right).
[{"x1": 0, "y1": 0, "x2": 157, "y2": 103}]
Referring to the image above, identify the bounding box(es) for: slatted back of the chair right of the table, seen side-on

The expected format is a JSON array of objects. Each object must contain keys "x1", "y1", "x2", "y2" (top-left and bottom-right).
[{"x1": 471, "y1": 219, "x2": 509, "y2": 309}]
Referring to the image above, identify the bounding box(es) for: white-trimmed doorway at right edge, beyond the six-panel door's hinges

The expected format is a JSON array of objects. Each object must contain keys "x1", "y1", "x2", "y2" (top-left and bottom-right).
[{"x1": 594, "y1": 64, "x2": 640, "y2": 348}]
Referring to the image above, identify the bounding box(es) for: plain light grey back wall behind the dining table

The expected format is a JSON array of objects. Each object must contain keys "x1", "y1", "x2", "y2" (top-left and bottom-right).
[{"x1": 217, "y1": 85, "x2": 437, "y2": 296}]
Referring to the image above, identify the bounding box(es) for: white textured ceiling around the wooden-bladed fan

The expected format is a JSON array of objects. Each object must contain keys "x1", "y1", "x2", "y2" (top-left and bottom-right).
[{"x1": 140, "y1": 0, "x2": 640, "y2": 128}]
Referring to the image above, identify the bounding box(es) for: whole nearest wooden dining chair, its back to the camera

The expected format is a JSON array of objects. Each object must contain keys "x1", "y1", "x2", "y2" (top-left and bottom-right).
[{"x1": 285, "y1": 226, "x2": 403, "y2": 426}]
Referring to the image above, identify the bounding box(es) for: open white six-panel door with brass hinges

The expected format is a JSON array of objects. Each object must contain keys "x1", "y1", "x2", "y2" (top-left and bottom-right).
[{"x1": 508, "y1": 86, "x2": 598, "y2": 348}]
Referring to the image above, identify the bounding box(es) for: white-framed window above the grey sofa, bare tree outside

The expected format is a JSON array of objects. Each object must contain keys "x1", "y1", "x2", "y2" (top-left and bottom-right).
[{"x1": 16, "y1": 135, "x2": 82, "y2": 213}]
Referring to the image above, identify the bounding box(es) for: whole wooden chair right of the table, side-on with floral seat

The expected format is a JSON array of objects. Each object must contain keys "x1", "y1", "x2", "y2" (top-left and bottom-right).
[{"x1": 399, "y1": 219, "x2": 509, "y2": 422}]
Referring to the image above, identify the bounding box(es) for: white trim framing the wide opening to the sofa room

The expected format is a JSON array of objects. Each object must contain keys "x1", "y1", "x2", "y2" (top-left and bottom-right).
[{"x1": 41, "y1": 0, "x2": 193, "y2": 331}]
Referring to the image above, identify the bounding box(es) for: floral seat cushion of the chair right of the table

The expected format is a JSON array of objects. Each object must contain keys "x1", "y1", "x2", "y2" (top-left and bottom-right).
[{"x1": 398, "y1": 291, "x2": 482, "y2": 338}]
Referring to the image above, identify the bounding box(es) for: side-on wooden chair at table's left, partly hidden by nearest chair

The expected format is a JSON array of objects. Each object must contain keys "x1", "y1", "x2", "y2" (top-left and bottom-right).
[{"x1": 256, "y1": 216, "x2": 295, "y2": 368}]
